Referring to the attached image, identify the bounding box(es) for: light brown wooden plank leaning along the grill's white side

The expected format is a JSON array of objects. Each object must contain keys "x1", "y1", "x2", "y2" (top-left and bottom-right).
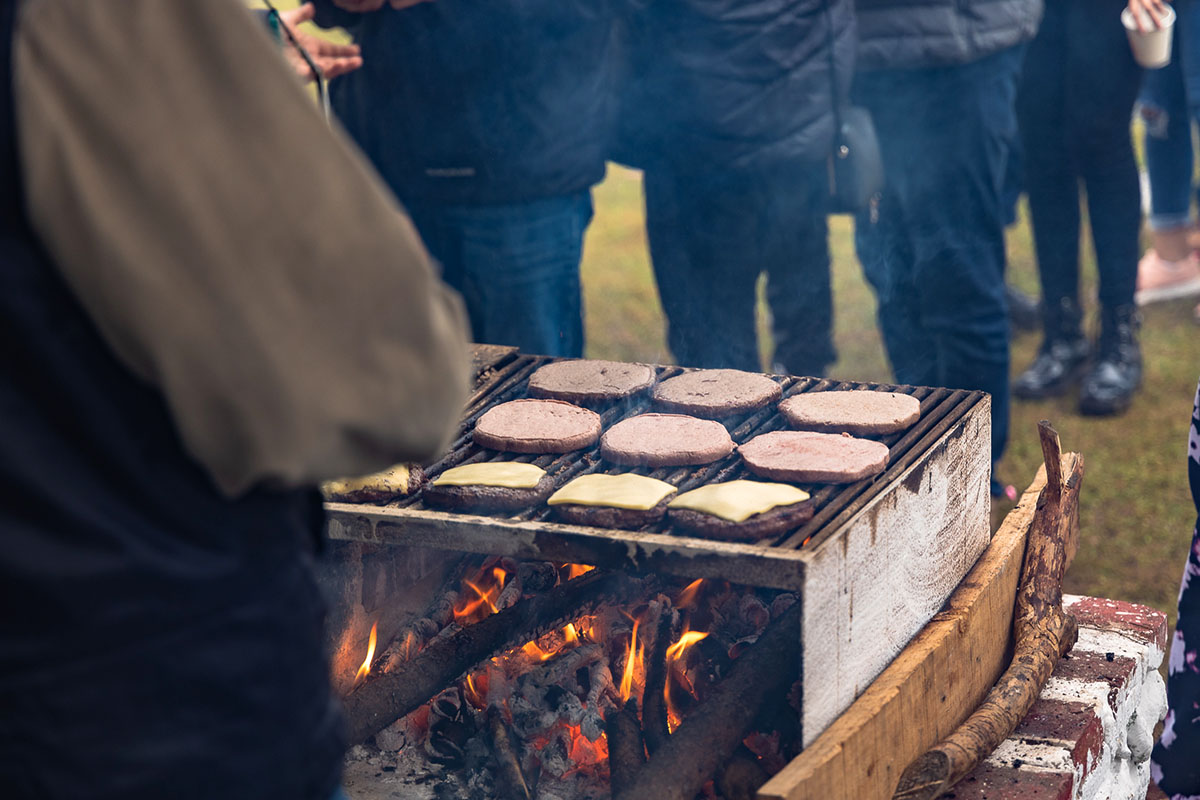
[{"x1": 758, "y1": 468, "x2": 1060, "y2": 800}]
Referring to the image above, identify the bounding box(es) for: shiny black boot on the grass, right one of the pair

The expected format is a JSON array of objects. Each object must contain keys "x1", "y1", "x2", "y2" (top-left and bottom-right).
[{"x1": 1079, "y1": 305, "x2": 1141, "y2": 415}]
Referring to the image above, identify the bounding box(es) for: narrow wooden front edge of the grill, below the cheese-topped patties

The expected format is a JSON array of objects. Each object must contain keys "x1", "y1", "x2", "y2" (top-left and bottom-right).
[{"x1": 325, "y1": 503, "x2": 804, "y2": 591}]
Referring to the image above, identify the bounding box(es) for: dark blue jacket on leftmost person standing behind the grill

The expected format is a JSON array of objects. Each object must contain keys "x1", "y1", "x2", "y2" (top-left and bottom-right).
[{"x1": 317, "y1": 0, "x2": 614, "y2": 205}]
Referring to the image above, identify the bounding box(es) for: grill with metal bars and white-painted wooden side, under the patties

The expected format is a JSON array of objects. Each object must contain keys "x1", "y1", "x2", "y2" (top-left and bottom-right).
[{"x1": 326, "y1": 350, "x2": 990, "y2": 742}]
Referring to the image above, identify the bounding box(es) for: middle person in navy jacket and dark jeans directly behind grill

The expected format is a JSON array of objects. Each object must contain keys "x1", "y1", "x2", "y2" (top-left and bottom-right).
[{"x1": 614, "y1": 0, "x2": 854, "y2": 375}]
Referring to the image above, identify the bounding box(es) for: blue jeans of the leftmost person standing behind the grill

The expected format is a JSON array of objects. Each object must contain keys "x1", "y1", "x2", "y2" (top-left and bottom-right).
[{"x1": 406, "y1": 192, "x2": 592, "y2": 357}]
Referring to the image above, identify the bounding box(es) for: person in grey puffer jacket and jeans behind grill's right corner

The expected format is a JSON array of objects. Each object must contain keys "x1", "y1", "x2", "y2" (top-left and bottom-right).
[{"x1": 854, "y1": 0, "x2": 1042, "y2": 497}]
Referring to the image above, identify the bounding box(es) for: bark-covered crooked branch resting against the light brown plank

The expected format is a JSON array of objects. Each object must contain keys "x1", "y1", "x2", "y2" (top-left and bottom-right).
[{"x1": 893, "y1": 420, "x2": 1084, "y2": 800}]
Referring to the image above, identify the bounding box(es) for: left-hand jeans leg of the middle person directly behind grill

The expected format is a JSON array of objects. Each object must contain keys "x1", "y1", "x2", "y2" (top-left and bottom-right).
[{"x1": 643, "y1": 169, "x2": 762, "y2": 372}]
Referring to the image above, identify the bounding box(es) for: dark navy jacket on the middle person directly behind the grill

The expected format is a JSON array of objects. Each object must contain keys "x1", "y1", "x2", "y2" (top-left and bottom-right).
[{"x1": 618, "y1": 0, "x2": 854, "y2": 170}]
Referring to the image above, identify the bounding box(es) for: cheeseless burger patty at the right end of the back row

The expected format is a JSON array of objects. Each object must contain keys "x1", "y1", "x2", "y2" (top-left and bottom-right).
[{"x1": 779, "y1": 391, "x2": 920, "y2": 435}]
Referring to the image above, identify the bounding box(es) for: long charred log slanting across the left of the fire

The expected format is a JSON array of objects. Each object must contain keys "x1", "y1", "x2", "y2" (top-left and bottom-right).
[{"x1": 344, "y1": 570, "x2": 631, "y2": 744}]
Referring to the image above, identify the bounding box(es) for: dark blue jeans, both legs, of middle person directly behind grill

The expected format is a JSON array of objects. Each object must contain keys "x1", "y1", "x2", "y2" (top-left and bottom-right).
[{"x1": 643, "y1": 163, "x2": 836, "y2": 375}]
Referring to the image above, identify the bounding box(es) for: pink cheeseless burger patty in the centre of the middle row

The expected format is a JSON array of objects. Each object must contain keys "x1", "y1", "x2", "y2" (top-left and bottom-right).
[{"x1": 600, "y1": 414, "x2": 733, "y2": 467}]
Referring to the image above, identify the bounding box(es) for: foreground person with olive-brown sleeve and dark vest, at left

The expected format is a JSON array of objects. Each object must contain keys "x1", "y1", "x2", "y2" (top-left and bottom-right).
[{"x1": 0, "y1": 0, "x2": 467, "y2": 800}]
